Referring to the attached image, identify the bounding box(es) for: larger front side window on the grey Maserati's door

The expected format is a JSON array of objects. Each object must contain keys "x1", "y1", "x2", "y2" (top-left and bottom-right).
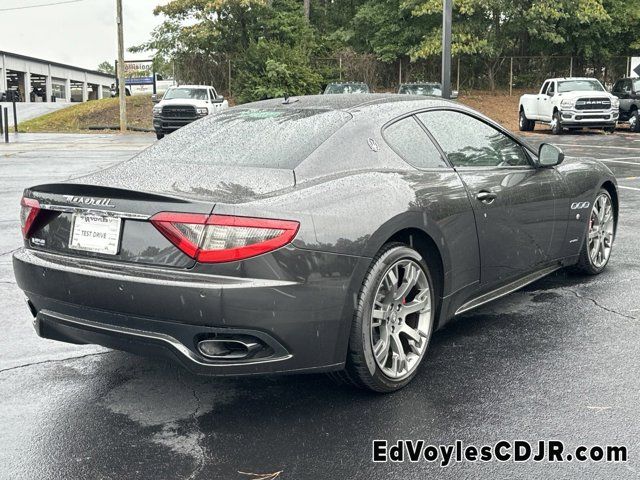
[{"x1": 418, "y1": 110, "x2": 531, "y2": 167}]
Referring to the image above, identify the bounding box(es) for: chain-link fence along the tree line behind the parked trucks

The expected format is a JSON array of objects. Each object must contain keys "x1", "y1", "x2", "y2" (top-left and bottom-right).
[{"x1": 173, "y1": 53, "x2": 630, "y2": 97}]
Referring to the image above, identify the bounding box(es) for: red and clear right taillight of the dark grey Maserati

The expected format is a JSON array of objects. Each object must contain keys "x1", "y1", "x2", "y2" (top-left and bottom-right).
[{"x1": 151, "y1": 212, "x2": 300, "y2": 263}]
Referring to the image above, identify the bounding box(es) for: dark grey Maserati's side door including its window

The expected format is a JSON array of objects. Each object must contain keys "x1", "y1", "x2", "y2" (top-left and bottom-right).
[{"x1": 417, "y1": 110, "x2": 566, "y2": 288}]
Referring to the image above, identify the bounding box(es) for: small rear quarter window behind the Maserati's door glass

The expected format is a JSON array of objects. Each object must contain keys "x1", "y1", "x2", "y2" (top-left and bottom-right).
[{"x1": 382, "y1": 117, "x2": 447, "y2": 168}]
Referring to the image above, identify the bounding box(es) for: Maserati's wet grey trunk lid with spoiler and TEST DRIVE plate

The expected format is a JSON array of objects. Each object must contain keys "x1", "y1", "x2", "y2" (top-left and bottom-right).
[{"x1": 25, "y1": 162, "x2": 295, "y2": 268}]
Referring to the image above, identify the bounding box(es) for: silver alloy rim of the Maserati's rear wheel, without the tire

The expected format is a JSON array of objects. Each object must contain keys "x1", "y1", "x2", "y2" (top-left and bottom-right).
[{"x1": 371, "y1": 259, "x2": 431, "y2": 380}]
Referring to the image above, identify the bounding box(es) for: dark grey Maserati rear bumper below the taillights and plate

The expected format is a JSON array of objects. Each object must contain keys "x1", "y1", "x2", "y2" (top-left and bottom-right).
[{"x1": 13, "y1": 249, "x2": 358, "y2": 375}]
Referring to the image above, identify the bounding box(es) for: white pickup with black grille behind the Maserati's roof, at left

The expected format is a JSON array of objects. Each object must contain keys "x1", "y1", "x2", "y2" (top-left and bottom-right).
[{"x1": 153, "y1": 85, "x2": 229, "y2": 140}]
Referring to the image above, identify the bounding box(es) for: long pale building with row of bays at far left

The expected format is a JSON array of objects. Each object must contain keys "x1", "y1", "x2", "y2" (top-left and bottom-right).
[{"x1": 0, "y1": 50, "x2": 115, "y2": 102}]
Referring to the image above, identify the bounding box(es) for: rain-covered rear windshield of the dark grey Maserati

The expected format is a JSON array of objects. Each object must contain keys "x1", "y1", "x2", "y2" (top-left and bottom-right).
[{"x1": 144, "y1": 108, "x2": 351, "y2": 169}]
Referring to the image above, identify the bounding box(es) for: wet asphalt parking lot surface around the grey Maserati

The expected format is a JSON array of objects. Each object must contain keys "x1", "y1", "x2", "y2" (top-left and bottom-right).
[{"x1": 0, "y1": 130, "x2": 640, "y2": 480}]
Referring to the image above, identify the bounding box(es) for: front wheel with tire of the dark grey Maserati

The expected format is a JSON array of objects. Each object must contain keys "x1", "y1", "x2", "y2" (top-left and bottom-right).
[{"x1": 576, "y1": 189, "x2": 616, "y2": 275}]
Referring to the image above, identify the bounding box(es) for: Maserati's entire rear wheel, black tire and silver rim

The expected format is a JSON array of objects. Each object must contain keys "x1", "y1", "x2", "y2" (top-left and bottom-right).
[{"x1": 334, "y1": 243, "x2": 435, "y2": 392}]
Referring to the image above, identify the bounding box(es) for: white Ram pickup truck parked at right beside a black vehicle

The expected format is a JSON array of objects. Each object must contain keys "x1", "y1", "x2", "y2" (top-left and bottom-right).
[{"x1": 519, "y1": 78, "x2": 620, "y2": 135}]
